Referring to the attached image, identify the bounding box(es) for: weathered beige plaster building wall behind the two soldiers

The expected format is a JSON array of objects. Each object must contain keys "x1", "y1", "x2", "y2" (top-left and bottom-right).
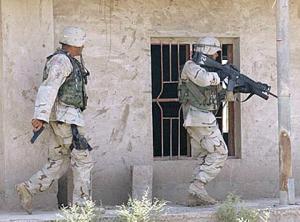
[{"x1": 0, "y1": 0, "x2": 300, "y2": 208}]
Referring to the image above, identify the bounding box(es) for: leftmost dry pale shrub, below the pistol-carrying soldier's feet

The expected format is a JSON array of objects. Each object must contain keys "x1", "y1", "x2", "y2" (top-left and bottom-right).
[{"x1": 56, "y1": 200, "x2": 103, "y2": 222}]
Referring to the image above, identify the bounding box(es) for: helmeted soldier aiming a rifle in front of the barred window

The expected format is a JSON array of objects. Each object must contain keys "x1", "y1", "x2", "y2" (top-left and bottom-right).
[{"x1": 179, "y1": 37, "x2": 228, "y2": 206}]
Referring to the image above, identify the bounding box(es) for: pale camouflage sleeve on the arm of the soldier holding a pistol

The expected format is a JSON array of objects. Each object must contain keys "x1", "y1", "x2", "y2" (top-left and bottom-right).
[{"x1": 33, "y1": 55, "x2": 72, "y2": 122}]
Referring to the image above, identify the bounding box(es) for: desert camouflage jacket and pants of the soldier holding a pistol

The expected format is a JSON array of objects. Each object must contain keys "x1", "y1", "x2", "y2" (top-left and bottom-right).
[{"x1": 25, "y1": 54, "x2": 93, "y2": 204}]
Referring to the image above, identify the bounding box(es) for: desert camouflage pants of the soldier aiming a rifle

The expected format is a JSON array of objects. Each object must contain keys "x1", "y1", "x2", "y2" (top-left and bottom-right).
[{"x1": 186, "y1": 124, "x2": 228, "y2": 184}]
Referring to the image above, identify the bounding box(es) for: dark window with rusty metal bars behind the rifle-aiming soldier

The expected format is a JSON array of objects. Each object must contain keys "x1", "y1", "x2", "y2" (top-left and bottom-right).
[{"x1": 151, "y1": 38, "x2": 240, "y2": 159}]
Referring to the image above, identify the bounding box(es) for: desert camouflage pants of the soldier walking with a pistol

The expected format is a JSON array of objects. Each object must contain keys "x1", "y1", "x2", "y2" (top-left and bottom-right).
[{"x1": 25, "y1": 122, "x2": 93, "y2": 204}]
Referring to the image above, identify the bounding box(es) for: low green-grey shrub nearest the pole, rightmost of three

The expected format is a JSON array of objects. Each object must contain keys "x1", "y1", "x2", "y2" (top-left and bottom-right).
[{"x1": 216, "y1": 194, "x2": 270, "y2": 222}]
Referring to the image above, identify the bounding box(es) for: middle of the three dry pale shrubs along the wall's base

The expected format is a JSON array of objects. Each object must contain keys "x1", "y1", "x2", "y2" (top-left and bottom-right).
[{"x1": 117, "y1": 191, "x2": 167, "y2": 222}]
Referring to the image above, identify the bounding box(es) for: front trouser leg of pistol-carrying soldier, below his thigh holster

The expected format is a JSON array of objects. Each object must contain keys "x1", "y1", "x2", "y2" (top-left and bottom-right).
[{"x1": 71, "y1": 127, "x2": 94, "y2": 205}]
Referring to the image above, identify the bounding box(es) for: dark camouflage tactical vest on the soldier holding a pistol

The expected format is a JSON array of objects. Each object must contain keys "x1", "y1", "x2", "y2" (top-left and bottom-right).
[{"x1": 43, "y1": 50, "x2": 89, "y2": 111}]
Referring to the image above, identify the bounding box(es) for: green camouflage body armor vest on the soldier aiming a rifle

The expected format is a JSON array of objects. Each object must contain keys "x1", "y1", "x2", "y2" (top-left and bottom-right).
[{"x1": 178, "y1": 65, "x2": 226, "y2": 111}]
